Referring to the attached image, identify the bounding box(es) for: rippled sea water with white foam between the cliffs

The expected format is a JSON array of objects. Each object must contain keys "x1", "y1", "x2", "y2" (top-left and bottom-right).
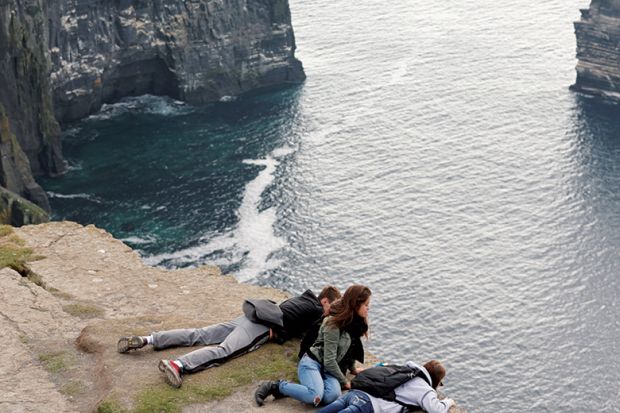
[{"x1": 43, "y1": 0, "x2": 620, "y2": 413}]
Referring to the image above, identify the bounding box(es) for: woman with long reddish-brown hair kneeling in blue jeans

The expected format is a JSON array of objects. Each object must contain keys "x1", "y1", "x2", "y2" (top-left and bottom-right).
[{"x1": 254, "y1": 285, "x2": 371, "y2": 406}]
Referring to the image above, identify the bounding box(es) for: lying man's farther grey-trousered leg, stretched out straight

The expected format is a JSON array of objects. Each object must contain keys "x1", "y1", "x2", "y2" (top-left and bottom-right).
[{"x1": 152, "y1": 316, "x2": 245, "y2": 350}]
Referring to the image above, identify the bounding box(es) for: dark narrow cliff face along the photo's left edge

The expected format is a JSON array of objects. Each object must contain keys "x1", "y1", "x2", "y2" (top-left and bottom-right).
[{"x1": 0, "y1": 0, "x2": 64, "y2": 210}]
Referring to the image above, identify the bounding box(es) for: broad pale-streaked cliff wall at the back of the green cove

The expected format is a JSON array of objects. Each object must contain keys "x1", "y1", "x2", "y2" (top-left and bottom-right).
[{"x1": 49, "y1": 0, "x2": 304, "y2": 122}]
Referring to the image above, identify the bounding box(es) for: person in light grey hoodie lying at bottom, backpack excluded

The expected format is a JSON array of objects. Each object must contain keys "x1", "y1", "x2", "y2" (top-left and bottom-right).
[{"x1": 317, "y1": 360, "x2": 455, "y2": 413}]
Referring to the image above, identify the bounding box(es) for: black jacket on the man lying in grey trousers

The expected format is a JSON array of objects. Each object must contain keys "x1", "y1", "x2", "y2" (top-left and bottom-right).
[{"x1": 275, "y1": 290, "x2": 323, "y2": 343}]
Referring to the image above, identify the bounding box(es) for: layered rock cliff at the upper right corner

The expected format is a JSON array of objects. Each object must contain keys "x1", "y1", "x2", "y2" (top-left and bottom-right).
[{"x1": 572, "y1": 0, "x2": 620, "y2": 99}]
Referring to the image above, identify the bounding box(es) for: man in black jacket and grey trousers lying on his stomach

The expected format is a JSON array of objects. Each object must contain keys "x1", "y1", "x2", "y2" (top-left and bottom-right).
[{"x1": 117, "y1": 286, "x2": 340, "y2": 388}]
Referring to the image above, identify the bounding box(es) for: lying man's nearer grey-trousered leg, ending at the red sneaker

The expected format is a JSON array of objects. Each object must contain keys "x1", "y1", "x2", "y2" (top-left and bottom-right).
[{"x1": 177, "y1": 316, "x2": 269, "y2": 373}]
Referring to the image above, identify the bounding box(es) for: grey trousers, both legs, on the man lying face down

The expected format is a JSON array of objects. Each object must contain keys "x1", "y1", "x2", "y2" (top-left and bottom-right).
[{"x1": 153, "y1": 315, "x2": 269, "y2": 373}]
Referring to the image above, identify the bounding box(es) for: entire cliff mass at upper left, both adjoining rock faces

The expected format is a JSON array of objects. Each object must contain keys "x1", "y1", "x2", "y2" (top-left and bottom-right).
[{"x1": 0, "y1": 0, "x2": 305, "y2": 219}]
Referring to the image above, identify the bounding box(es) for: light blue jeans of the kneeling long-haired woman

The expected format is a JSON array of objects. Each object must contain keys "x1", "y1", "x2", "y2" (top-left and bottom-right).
[{"x1": 278, "y1": 355, "x2": 342, "y2": 406}]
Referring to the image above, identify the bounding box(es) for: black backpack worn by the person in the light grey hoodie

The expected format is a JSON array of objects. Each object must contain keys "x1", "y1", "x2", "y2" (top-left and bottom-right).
[{"x1": 351, "y1": 364, "x2": 431, "y2": 412}]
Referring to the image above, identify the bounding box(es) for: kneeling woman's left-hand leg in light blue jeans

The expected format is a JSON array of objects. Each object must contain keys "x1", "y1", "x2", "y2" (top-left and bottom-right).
[{"x1": 278, "y1": 356, "x2": 324, "y2": 406}]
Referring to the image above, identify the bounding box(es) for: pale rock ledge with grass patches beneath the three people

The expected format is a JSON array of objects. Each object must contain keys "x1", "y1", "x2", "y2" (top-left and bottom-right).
[{"x1": 0, "y1": 222, "x2": 462, "y2": 413}]
